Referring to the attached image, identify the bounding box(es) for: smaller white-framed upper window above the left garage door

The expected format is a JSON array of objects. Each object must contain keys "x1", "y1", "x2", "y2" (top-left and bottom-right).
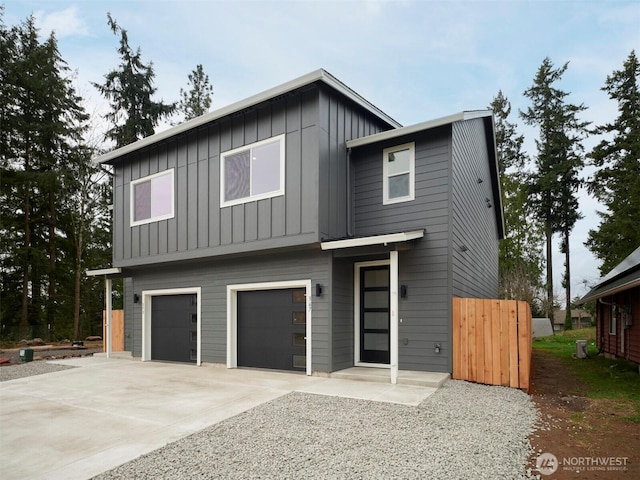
[{"x1": 131, "y1": 169, "x2": 174, "y2": 227}]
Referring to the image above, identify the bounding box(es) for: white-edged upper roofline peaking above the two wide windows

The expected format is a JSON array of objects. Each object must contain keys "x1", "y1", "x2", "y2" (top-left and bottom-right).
[{"x1": 94, "y1": 68, "x2": 402, "y2": 163}]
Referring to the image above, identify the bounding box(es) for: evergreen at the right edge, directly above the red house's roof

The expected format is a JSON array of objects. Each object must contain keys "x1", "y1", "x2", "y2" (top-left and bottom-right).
[{"x1": 586, "y1": 51, "x2": 640, "y2": 275}]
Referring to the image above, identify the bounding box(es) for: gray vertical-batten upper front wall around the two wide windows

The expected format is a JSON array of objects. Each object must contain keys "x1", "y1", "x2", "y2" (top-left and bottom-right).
[{"x1": 114, "y1": 87, "x2": 319, "y2": 267}]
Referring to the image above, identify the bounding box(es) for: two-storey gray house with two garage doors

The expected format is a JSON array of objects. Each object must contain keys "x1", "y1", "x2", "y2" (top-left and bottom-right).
[{"x1": 92, "y1": 70, "x2": 503, "y2": 382}]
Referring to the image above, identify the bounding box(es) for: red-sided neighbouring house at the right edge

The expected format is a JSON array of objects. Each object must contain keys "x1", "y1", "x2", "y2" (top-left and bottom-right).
[{"x1": 580, "y1": 247, "x2": 640, "y2": 369}]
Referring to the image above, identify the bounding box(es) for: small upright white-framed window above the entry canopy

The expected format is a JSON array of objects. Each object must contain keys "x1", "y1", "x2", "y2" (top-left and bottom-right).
[{"x1": 382, "y1": 143, "x2": 415, "y2": 205}]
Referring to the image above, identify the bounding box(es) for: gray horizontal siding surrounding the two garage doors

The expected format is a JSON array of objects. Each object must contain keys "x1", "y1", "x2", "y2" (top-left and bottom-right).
[{"x1": 125, "y1": 250, "x2": 331, "y2": 372}]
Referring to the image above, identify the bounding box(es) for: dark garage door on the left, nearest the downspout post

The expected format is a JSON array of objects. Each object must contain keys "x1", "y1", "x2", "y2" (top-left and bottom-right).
[{"x1": 151, "y1": 294, "x2": 198, "y2": 362}]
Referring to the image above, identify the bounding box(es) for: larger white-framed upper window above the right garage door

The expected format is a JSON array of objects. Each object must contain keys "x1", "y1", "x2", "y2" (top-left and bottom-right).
[{"x1": 220, "y1": 135, "x2": 284, "y2": 207}]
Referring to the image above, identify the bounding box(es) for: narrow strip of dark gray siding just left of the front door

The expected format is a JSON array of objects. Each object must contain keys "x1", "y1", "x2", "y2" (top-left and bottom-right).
[{"x1": 331, "y1": 258, "x2": 354, "y2": 371}]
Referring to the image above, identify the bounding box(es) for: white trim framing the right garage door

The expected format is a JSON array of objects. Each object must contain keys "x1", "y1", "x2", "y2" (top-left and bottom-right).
[{"x1": 227, "y1": 280, "x2": 312, "y2": 375}]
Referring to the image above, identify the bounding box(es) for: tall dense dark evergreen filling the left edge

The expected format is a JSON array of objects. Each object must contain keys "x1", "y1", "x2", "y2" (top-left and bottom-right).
[{"x1": 0, "y1": 17, "x2": 87, "y2": 336}]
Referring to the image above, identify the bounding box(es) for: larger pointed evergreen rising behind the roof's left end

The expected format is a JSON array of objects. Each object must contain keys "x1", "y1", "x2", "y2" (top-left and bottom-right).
[{"x1": 92, "y1": 14, "x2": 176, "y2": 147}]
